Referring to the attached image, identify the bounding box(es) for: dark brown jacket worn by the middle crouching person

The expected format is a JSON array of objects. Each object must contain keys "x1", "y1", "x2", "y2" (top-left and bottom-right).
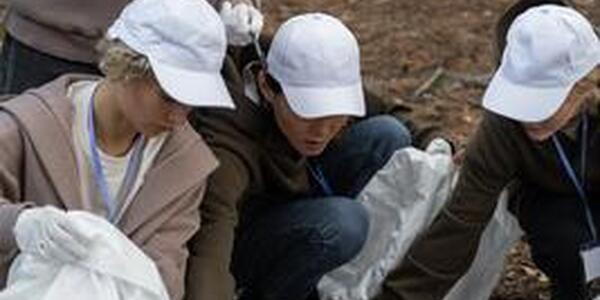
[{"x1": 186, "y1": 55, "x2": 446, "y2": 300}]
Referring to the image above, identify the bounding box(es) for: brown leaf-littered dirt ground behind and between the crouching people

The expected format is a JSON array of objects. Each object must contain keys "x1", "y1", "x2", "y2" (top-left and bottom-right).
[{"x1": 263, "y1": 0, "x2": 600, "y2": 300}]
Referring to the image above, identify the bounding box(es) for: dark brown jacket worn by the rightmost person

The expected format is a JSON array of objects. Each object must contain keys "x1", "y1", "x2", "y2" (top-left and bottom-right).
[{"x1": 377, "y1": 104, "x2": 600, "y2": 300}]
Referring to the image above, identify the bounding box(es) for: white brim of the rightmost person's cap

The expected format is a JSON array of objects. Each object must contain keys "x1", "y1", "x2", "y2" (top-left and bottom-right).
[{"x1": 483, "y1": 69, "x2": 574, "y2": 122}]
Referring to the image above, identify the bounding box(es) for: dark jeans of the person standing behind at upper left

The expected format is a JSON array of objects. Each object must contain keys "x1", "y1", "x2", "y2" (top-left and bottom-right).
[{"x1": 0, "y1": 34, "x2": 100, "y2": 94}]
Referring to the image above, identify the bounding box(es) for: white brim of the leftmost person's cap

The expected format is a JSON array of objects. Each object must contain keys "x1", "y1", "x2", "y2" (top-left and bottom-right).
[{"x1": 148, "y1": 55, "x2": 235, "y2": 109}]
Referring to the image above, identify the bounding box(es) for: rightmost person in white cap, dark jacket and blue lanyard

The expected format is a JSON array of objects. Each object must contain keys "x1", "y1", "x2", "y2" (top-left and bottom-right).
[{"x1": 376, "y1": 1, "x2": 600, "y2": 300}]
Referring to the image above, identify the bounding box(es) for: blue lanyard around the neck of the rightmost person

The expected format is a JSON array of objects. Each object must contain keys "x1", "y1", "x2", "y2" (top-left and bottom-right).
[{"x1": 552, "y1": 114, "x2": 598, "y2": 241}]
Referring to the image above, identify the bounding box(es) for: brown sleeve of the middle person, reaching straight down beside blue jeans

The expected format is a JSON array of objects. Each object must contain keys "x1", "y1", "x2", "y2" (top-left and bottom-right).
[{"x1": 186, "y1": 148, "x2": 249, "y2": 300}]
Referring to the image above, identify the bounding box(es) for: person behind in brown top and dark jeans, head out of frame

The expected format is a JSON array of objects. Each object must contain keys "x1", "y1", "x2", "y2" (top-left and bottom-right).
[{"x1": 0, "y1": 0, "x2": 263, "y2": 94}]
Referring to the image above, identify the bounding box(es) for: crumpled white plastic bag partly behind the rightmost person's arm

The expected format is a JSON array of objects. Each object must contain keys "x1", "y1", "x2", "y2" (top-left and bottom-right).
[{"x1": 319, "y1": 140, "x2": 522, "y2": 300}]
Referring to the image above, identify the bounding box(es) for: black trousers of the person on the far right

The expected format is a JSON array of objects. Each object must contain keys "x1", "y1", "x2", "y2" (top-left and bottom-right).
[{"x1": 519, "y1": 195, "x2": 600, "y2": 300}]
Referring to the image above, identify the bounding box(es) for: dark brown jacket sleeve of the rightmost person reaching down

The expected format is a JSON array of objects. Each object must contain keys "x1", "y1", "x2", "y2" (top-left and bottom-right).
[{"x1": 377, "y1": 115, "x2": 518, "y2": 300}]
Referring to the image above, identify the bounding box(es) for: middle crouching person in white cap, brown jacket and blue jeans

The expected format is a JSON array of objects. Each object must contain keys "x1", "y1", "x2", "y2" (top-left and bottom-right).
[{"x1": 186, "y1": 13, "x2": 411, "y2": 300}]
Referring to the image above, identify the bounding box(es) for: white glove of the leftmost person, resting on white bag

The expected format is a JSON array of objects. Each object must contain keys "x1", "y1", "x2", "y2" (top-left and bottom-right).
[{"x1": 13, "y1": 206, "x2": 92, "y2": 262}]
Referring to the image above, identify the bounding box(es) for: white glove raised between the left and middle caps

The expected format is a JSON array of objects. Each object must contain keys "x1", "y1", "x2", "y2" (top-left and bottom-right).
[{"x1": 221, "y1": 1, "x2": 264, "y2": 46}]
